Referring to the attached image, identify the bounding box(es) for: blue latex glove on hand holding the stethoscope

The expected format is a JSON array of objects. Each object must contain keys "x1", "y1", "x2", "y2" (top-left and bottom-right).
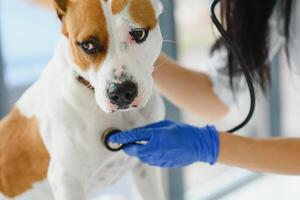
[{"x1": 109, "y1": 121, "x2": 220, "y2": 168}]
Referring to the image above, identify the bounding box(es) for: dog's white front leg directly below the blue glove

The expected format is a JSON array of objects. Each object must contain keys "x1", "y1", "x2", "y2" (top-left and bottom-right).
[{"x1": 133, "y1": 163, "x2": 166, "y2": 200}]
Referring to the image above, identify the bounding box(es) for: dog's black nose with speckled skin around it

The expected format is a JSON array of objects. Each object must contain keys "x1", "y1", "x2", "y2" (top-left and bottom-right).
[{"x1": 107, "y1": 81, "x2": 138, "y2": 109}]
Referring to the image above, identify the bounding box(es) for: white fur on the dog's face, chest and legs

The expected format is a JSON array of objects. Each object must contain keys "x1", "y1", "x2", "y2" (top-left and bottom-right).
[{"x1": 0, "y1": 0, "x2": 164, "y2": 200}]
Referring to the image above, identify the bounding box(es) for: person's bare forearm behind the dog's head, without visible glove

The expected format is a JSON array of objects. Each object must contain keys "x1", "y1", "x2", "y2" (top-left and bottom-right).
[{"x1": 153, "y1": 54, "x2": 228, "y2": 121}]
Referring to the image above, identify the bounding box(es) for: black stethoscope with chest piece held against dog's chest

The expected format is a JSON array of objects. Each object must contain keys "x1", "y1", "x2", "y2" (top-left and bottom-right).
[{"x1": 102, "y1": 0, "x2": 256, "y2": 152}]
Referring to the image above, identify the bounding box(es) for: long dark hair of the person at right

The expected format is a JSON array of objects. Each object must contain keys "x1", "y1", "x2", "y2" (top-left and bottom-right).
[{"x1": 212, "y1": 0, "x2": 294, "y2": 91}]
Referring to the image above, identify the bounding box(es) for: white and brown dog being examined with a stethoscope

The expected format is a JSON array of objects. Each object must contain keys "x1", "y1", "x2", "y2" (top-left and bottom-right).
[{"x1": 0, "y1": 0, "x2": 165, "y2": 200}]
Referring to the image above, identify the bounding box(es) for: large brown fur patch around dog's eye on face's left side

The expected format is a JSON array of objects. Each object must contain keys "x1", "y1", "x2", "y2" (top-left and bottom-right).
[{"x1": 56, "y1": 0, "x2": 109, "y2": 70}]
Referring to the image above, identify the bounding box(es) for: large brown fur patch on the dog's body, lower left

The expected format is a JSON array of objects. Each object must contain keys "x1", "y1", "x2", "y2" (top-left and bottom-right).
[{"x1": 0, "y1": 108, "x2": 50, "y2": 198}]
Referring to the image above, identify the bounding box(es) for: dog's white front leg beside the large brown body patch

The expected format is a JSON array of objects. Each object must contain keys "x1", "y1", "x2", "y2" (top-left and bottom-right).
[{"x1": 48, "y1": 124, "x2": 88, "y2": 200}]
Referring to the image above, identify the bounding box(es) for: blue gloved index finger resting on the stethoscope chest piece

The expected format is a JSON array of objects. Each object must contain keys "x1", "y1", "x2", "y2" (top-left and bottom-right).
[{"x1": 108, "y1": 129, "x2": 152, "y2": 144}]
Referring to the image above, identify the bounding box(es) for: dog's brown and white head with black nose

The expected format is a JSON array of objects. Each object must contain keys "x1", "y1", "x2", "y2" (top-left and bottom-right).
[{"x1": 55, "y1": 0, "x2": 162, "y2": 113}]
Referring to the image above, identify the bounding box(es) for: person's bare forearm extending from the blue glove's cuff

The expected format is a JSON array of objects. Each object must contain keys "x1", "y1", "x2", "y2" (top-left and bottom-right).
[{"x1": 219, "y1": 133, "x2": 300, "y2": 175}]
